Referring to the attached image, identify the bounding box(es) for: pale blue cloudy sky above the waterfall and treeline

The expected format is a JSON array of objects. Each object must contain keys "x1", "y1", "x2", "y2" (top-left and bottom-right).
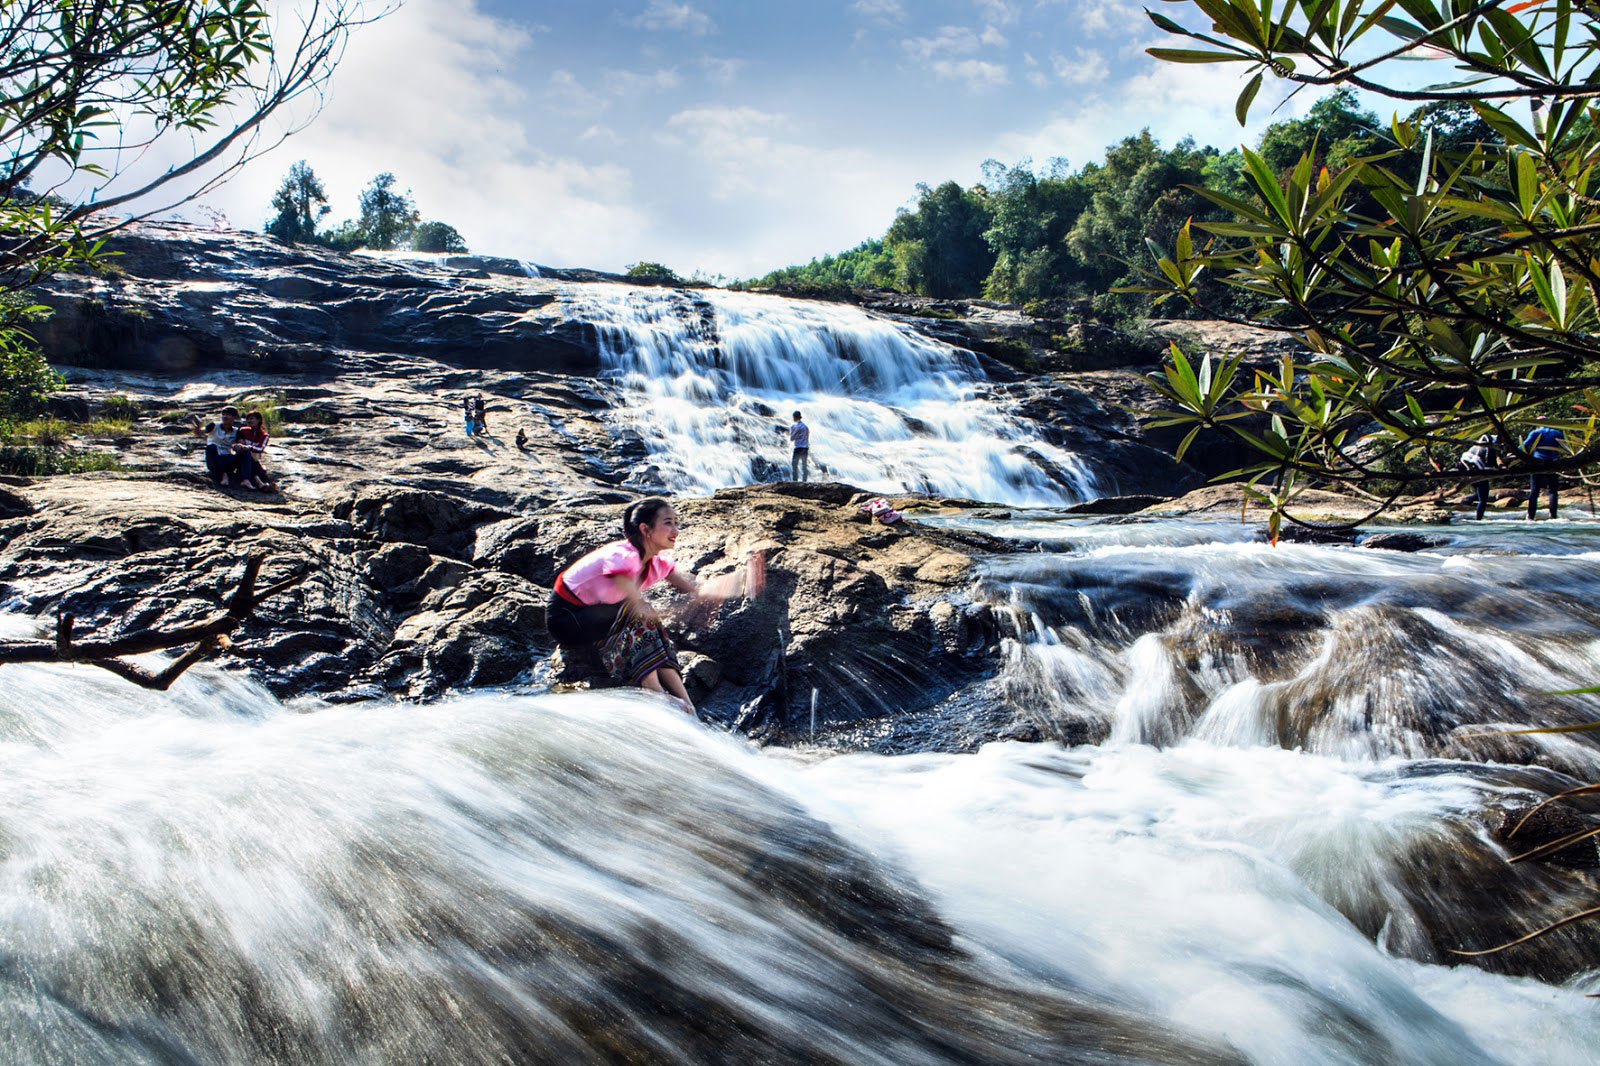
[{"x1": 189, "y1": 0, "x2": 1312, "y2": 277}]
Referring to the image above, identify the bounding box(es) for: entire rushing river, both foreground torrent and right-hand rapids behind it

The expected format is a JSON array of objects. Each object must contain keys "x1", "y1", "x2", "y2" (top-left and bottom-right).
[{"x1": 9, "y1": 512, "x2": 1600, "y2": 1066}]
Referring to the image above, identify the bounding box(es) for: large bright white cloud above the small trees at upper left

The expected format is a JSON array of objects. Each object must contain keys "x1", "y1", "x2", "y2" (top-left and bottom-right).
[{"x1": 164, "y1": 0, "x2": 653, "y2": 266}]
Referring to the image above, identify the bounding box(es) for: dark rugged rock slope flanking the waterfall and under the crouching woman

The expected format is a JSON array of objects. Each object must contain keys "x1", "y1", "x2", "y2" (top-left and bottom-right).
[{"x1": 0, "y1": 226, "x2": 1478, "y2": 746}]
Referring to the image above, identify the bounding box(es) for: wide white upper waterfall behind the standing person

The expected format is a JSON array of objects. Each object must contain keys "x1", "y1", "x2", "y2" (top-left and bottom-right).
[{"x1": 565, "y1": 285, "x2": 1099, "y2": 504}]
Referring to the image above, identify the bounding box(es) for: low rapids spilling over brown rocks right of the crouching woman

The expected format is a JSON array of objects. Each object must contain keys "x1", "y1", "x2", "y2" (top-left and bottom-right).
[{"x1": 960, "y1": 508, "x2": 1600, "y2": 778}]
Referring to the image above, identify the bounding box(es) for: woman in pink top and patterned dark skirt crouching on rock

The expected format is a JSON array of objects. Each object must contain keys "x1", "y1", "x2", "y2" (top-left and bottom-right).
[{"x1": 546, "y1": 498, "x2": 763, "y2": 714}]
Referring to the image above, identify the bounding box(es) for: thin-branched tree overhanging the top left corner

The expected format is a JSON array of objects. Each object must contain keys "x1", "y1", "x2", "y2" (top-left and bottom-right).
[{"x1": 0, "y1": 0, "x2": 382, "y2": 416}]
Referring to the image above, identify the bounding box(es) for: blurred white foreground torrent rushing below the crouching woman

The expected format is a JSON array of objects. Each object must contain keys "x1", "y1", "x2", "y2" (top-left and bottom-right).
[{"x1": 0, "y1": 656, "x2": 1600, "y2": 1066}]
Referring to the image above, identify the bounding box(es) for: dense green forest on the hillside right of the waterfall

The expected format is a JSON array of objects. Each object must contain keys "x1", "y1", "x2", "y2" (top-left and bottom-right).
[{"x1": 746, "y1": 90, "x2": 1499, "y2": 319}]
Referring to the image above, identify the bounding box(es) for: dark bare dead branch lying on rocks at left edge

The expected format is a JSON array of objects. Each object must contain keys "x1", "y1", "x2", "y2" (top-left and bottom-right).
[{"x1": 0, "y1": 555, "x2": 309, "y2": 691}]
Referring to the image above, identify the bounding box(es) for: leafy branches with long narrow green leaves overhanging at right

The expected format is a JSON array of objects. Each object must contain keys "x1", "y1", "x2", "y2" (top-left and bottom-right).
[{"x1": 1150, "y1": 0, "x2": 1600, "y2": 528}]
